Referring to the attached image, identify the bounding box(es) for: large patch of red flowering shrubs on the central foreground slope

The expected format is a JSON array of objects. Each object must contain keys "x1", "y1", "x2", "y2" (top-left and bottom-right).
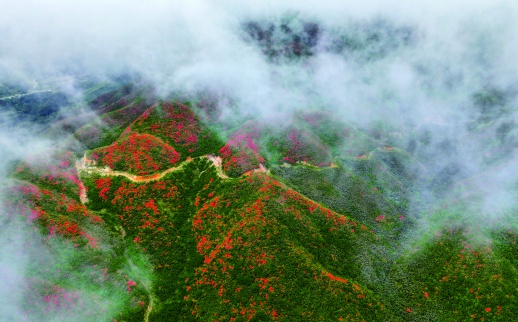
[{"x1": 185, "y1": 174, "x2": 380, "y2": 321}]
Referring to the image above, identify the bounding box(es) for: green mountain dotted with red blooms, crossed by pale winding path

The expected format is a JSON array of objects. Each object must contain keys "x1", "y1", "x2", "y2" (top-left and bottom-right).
[{"x1": 0, "y1": 81, "x2": 518, "y2": 321}]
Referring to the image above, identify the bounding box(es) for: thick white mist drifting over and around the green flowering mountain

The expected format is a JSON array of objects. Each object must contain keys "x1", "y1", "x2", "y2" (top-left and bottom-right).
[{"x1": 0, "y1": 0, "x2": 518, "y2": 316}]
